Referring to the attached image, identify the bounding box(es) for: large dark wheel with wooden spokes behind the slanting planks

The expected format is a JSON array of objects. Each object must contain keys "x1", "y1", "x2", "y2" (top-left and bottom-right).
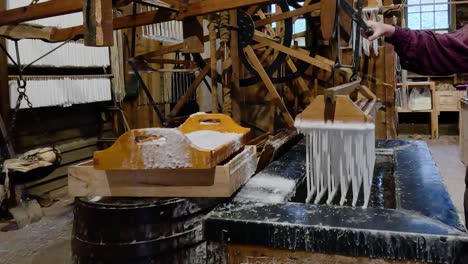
[{"x1": 193, "y1": 1, "x2": 317, "y2": 86}]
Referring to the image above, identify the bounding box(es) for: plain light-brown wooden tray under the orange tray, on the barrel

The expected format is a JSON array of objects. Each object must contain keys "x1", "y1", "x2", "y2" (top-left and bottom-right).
[{"x1": 68, "y1": 145, "x2": 257, "y2": 197}]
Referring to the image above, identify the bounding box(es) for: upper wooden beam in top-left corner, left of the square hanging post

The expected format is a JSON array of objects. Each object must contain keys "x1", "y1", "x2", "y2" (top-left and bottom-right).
[{"x1": 0, "y1": 0, "x2": 82, "y2": 26}]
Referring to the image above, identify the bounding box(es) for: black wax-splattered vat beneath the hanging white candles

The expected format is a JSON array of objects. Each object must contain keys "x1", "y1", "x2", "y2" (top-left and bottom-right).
[{"x1": 204, "y1": 140, "x2": 468, "y2": 263}]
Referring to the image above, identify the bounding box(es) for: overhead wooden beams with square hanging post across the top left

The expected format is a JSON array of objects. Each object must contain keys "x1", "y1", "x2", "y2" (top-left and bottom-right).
[{"x1": 0, "y1": 0, "x2": 269, "y2": 43}]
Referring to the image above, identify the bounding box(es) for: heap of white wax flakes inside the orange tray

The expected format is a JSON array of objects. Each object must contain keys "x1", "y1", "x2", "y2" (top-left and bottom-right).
[{"x1": 185, "y1": 130, "x2": 242, "y2": 150}]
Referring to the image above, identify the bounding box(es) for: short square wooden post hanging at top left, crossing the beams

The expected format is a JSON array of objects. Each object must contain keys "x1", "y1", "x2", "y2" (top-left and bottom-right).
[{"x1": 82, "y1": 0, "x2": 114, "y2": 47}]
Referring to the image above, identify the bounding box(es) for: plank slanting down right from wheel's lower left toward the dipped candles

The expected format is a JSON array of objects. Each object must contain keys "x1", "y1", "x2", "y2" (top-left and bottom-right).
[{"x1": 244, "y1": 46, "x2": 294, "y2": 127}]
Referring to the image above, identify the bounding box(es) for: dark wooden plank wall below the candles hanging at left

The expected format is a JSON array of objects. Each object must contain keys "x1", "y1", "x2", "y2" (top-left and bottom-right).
[{"x1": 9, "y1": 103, "x2": 112, "y2": 199}]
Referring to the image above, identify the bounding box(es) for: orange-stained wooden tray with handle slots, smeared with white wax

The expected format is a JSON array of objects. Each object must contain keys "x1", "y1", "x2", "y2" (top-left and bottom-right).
[{"x1": 94, "y1": 113, "x2": 250, "y2": 170}]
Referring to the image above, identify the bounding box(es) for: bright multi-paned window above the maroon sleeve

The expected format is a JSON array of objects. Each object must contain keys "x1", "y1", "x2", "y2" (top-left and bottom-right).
[{"x1": 407, "y1": 0, "x2": 450, "y2": 33}]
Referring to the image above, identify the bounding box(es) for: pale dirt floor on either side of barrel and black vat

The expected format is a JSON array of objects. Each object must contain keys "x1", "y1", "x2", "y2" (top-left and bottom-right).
[{"x1": 0, "y1": 136, "x2": 465, "y2": 264}]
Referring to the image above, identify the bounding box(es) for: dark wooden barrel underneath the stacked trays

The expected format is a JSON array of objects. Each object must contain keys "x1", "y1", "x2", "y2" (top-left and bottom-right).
[{"x1": 72, "y1": 197, "x2": 221, "y2": 264}]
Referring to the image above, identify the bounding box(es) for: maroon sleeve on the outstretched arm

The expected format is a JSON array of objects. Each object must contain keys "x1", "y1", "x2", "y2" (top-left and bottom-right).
[{"x1": 385, "y1": 25, "x2": 468, "y2": 75}]
